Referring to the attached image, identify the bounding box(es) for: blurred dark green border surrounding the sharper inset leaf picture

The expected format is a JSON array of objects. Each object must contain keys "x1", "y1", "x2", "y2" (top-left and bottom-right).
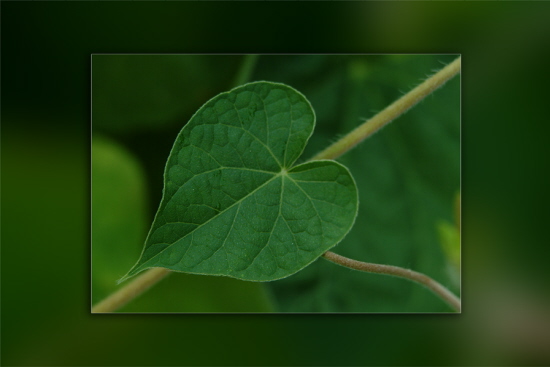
[{"x1": 1, "y1": 2, "x2": 550, "y2": 366}]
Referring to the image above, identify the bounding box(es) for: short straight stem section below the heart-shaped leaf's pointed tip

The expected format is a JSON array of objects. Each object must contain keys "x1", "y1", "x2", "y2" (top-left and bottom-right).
[{"x1": 92, "y1": 268, "x2": 170, "y2": 313}]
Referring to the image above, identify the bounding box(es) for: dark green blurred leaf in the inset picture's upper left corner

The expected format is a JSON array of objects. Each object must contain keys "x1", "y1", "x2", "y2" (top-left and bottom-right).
[{"x1": 92, "y1": 55, "x2": 240, "y2": 132}]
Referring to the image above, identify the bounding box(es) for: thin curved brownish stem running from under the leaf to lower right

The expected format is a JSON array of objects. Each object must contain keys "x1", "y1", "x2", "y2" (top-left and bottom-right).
[{"x1": 323, "y1": 251, "x2": 460, "y2": 312}]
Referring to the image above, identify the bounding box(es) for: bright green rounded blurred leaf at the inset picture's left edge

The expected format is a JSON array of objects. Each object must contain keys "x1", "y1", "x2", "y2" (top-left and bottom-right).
[{"x1": 92, "y1": 136, "x2": 147, "y2": 303}]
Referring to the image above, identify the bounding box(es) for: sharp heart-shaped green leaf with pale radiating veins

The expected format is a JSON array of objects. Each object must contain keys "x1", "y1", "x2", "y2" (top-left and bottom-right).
[{"x1": 121, "y1": 82, "x2": 358, "y2": 281}]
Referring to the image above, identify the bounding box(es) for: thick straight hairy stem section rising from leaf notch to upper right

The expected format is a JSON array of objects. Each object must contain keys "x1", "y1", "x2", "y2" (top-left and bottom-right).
[{"x1": 311, "y1": 57, "x2": 461, "y2": 161}]
